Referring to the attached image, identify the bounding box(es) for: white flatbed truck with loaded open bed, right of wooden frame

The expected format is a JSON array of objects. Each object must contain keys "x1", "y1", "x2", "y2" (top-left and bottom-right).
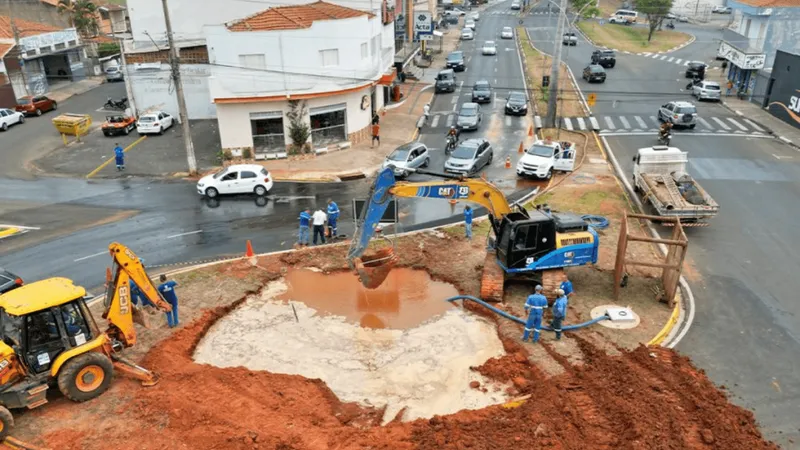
[{"x1": 633, "y1": 145, "x2": 719, "y2": 227}]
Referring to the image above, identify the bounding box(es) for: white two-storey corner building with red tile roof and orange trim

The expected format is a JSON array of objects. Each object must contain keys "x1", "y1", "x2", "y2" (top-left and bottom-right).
[{"x1": 205, "y1": 1, "x2": 394, "y2": 154}]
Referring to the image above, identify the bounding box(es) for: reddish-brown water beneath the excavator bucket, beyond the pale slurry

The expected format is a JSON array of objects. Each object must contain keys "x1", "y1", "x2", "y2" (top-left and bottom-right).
[{"x1": 280, "y1": 268, "x2": 458, "y2": 329}]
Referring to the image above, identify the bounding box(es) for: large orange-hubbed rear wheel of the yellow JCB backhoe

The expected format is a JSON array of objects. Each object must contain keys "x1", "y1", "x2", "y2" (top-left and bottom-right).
[{"x1": 58, "y1": 352, "x2": 114, "y2": 402}]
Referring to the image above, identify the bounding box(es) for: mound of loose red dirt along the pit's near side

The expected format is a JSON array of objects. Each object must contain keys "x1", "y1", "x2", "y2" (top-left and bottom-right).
[{"x1": 36, "y1": 286, "x2": 777, "y2": 450}]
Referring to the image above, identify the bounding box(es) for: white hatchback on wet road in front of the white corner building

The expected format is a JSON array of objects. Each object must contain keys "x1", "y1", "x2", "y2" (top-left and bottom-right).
[{"x1": 197, "y1": 164, "x2": 274, "y2": 198}]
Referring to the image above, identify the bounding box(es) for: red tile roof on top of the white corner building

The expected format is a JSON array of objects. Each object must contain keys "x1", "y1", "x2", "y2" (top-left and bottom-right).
[{"x1": 228, "y1": 1, "x2": 373, "y2": 31}]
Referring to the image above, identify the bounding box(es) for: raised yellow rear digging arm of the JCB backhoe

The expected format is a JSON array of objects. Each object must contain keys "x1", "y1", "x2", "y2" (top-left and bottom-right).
[{"x1": 103, "y1": 242, "x2": 172, "y2": 347}]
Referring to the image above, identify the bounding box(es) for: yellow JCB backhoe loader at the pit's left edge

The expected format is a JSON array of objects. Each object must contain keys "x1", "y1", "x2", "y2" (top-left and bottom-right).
[{"x1": 0, "y1": 242, "x2": 172, "y2": 441}]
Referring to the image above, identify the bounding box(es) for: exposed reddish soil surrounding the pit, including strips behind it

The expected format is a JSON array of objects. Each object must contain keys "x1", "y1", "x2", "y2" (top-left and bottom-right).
[{"x1": 10, "y1": 232, "x2": 776, "y2": 450}]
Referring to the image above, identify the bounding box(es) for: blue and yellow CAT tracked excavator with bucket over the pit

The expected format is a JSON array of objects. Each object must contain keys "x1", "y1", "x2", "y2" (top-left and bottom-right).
[{"x1": 347, "y1": 167, "x2": 600, "y2": 302}]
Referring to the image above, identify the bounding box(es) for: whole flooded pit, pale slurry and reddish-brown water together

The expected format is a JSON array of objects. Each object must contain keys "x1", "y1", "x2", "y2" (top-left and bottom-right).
[{"x1": 194, "y1": 269, "x2": 507, "y2": 421}]
